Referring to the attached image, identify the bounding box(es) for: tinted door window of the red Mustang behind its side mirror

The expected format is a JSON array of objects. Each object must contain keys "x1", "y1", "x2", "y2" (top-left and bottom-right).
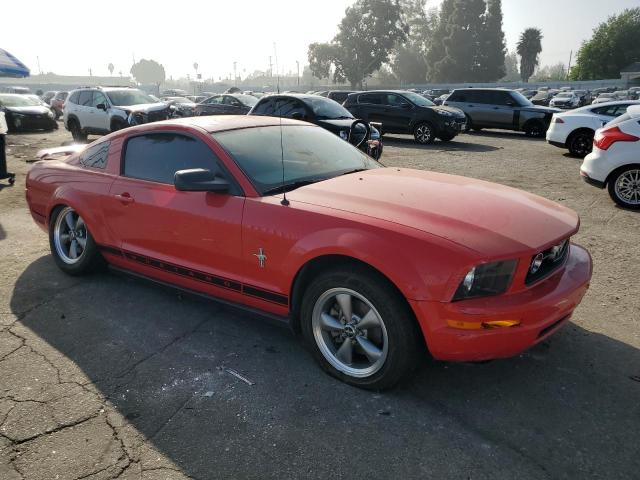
[{"x1": 123, "y1": 133, "x2": 222, "y2": 185}]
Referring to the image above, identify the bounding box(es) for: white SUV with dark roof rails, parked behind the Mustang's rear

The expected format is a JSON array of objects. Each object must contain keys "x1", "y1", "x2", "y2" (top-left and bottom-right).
[{"x1": 63, "y1": 87, "x2": 171, "y2": 141}]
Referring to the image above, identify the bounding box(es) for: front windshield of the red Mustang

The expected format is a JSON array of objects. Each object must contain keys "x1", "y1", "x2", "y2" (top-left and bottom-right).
[{"x1": 213, "y1": 125, "x2": 380, "y2": 195}]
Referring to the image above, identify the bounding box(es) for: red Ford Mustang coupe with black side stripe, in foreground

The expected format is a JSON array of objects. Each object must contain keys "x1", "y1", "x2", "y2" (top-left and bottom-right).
[{"x1": 27, "y1": 116, "x2": 592, "y2": 389}]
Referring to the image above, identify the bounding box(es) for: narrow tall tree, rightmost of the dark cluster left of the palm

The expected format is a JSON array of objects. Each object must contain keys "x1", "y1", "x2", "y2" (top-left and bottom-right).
[{"x1": 476, "y1": 0, "x2": 507, "y2": 82}]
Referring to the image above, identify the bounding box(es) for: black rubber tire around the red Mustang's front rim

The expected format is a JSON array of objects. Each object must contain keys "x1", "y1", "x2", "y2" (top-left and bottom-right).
[{"x1": 300, "y1": 267, "x2": 421, "y2": 390}]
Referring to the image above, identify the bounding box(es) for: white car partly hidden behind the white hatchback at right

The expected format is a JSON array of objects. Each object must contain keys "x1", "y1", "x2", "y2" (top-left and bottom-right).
[{"x1": 547, "y1": 100, "x2": 640, "y2": 158}]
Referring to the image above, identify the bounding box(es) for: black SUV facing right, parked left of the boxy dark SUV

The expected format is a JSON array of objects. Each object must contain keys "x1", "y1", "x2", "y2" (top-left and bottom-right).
[{"x1": 343, "y1": 90, "x2": 466, "y2": 144}]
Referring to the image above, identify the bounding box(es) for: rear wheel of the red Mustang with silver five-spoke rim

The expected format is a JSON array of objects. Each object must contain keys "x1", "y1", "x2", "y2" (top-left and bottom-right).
[{"x1": 49, "y1": 207, "x2": 102, "y2": 275}]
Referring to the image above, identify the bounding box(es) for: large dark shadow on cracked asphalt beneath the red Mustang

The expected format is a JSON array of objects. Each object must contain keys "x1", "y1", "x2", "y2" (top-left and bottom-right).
[{"x1": 11, "y1": 256, "x2": 640, "y2": 479}]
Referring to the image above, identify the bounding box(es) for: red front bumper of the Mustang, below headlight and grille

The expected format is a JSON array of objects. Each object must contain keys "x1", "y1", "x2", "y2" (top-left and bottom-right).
[{"x1": 410, "y1": 244, "x2": 592, "y2": 361}]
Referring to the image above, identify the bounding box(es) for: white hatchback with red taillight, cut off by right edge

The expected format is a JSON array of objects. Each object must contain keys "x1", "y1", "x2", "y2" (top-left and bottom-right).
[{"x1": 580, "y1": 105, "x2": 640, "y2": 209}]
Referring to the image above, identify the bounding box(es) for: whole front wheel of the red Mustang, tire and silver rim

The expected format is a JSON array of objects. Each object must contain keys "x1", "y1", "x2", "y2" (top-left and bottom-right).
[{"x1": 301, "y1": 269, "x2": 420, "y2": 390}]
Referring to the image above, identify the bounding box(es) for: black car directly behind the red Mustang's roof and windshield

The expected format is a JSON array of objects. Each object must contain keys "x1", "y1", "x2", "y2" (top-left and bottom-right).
[{"x1": 249, "y1": 93, "x2": 382, "y2": 160}]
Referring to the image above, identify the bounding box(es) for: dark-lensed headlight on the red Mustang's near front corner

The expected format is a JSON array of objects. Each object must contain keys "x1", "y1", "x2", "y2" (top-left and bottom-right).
[{"x1": 453, "y1": 260, "x2": 518, "y2": 302}]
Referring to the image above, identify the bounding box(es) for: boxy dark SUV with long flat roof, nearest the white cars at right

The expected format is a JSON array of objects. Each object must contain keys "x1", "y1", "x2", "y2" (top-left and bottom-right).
[{"x1": 444, "y1": 88, "x2": 560, "y2": 137}]
